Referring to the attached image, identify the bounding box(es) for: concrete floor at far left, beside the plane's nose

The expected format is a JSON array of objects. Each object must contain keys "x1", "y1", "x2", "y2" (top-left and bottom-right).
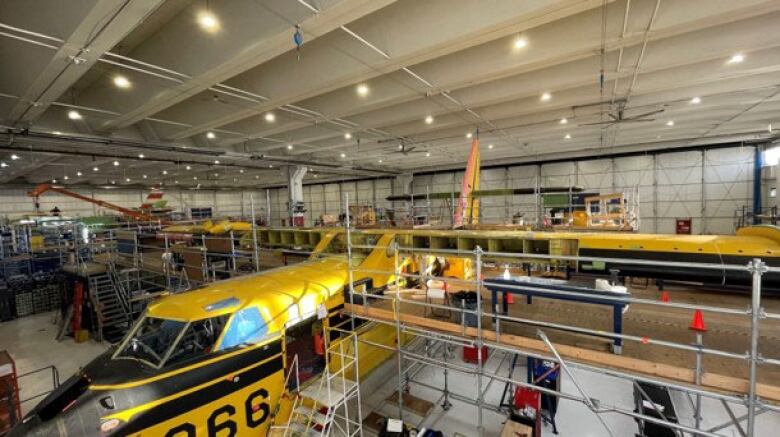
[{"x1": 0, "y1": 312, "x2": 107, "y2": 413}]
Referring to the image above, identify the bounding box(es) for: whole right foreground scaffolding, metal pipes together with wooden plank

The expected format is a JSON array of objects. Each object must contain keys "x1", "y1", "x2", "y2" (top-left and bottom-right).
[{"x1": 344, "y1": 196, "x2": 780, "y2": 437}]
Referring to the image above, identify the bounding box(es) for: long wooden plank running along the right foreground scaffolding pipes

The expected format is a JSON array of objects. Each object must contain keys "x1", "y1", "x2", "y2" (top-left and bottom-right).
[{"x1": 344, "y1": 303, "x2": 780, "y2": 402}]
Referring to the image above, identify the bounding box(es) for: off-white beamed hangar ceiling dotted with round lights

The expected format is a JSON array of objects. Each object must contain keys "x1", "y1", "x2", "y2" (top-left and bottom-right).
[{"x1": 0, "y1": 0, "x2": 780, "y2": 187}]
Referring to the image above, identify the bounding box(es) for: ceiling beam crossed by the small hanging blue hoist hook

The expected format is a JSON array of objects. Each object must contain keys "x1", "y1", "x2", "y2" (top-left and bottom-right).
[{"x1": 104, "y1": 0, "x2": 396, "y2": 129}]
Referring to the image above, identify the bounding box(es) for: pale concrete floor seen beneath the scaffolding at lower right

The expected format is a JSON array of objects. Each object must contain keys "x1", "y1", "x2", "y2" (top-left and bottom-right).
[{"x1": 361, "y1": 338, "x2": 780, "y2": 437}]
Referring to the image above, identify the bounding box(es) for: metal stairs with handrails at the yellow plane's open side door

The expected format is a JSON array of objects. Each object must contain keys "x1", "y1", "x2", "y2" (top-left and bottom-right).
[{"x1": 268, "y1": 328, "x2": 363, "y2": 437}]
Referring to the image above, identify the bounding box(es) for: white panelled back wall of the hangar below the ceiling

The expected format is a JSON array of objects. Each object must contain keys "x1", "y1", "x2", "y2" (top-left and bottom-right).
[{"x1": 0, "y1": 146, "x2": 754, "y2": 234}]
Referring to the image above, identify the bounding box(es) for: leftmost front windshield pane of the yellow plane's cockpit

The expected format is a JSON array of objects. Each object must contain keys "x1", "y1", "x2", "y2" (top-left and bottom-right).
[{"x1": 116, "y1": 317, "x2": 186, "y2": 367}]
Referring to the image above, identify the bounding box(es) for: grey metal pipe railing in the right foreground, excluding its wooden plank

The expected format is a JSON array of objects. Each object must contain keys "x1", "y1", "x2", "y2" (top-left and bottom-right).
[{"x1": 345, "y1": 196, "x2": 780, "y2": 436}]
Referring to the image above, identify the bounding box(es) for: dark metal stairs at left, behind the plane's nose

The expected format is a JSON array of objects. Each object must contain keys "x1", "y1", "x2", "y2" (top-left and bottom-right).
[{"x1": 88, "y1": 266, "x2": 132, "y2": 343}]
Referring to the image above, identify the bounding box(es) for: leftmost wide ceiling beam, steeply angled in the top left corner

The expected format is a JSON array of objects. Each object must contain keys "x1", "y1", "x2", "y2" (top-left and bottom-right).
[{"x1": 9, "y1": 0, "x2": 164, "y2": 126}]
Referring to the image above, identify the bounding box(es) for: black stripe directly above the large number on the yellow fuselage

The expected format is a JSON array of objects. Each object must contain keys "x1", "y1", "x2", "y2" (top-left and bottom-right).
[{"x1": 117, "y1": 356, "x2": 283, "y2": 435}]
